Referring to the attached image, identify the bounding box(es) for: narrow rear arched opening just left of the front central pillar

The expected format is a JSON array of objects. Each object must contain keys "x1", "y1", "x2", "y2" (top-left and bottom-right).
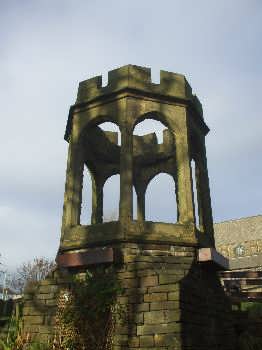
[{"x1": 103, "y1": 174, "x2": 120, "y2": 222}]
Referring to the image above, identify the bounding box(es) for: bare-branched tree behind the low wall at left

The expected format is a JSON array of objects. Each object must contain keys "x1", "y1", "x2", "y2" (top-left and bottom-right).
[{"x1": 8, "y1": 257, "x2": 56, "y2": 293}]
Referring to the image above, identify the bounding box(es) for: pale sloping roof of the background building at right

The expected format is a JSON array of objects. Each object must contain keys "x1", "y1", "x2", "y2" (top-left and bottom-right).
[{"x1": 214, "y1": 215, "x2": 262, "y2": 246}]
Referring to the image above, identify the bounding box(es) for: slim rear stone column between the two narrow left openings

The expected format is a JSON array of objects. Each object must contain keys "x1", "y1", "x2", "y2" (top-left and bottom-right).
[{"x1": 91, "y1": 175, "x2": 104, "y2": 225}]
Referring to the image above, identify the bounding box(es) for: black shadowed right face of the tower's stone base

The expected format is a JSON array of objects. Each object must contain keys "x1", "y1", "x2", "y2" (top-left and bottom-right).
[{"x1": 179, "y1": 262, "x2": 235, "y2": 350}]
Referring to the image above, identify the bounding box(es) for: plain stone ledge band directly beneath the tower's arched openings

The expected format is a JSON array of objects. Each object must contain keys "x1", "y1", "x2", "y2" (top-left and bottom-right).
[{"x1": 60, "y1": 221, "x2": 197, "y2": 252}]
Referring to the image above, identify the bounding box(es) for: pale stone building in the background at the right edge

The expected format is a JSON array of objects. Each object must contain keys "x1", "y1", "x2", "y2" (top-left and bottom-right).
[{"x1": 214, "y1": 215, "x2": 262, "y2": 303}]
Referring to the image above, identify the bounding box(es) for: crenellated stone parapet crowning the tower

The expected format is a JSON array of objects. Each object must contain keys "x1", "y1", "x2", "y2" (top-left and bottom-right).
[{"x1": 76, "y1": 64, "x2": 203, "y2": 116}]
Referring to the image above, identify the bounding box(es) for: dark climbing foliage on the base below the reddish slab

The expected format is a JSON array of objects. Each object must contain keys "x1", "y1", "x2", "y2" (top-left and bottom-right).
[{"x1": 56, "y1": 267, "x2": 125, "y2": 350}]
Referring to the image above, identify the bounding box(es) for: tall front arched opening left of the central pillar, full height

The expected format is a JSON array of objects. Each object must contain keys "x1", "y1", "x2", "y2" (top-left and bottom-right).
[{"x1": 80, "y1": 116, "x2": 121, "y2": 224}]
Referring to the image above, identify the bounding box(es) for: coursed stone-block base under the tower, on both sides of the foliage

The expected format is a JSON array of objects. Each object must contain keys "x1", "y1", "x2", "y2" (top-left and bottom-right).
[{"x1": 24, "y1": 243, "x2": 235, "y2": 350}]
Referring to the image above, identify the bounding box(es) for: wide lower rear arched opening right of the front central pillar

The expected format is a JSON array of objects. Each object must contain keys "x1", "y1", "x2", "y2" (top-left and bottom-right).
[{"x1": 145, "y1": 173, "x2": 177, "y2": 223}]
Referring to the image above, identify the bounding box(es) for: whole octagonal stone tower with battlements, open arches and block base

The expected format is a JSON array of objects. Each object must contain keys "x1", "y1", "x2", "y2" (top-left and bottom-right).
[{"x1": 23, "y1": 65, "x2": 233, "y2": 350}]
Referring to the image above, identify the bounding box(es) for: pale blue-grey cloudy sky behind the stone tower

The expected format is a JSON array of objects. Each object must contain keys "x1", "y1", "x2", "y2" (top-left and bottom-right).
[{"x1": 0, "y1": 0, "x2": 262, "y2": 268}]
